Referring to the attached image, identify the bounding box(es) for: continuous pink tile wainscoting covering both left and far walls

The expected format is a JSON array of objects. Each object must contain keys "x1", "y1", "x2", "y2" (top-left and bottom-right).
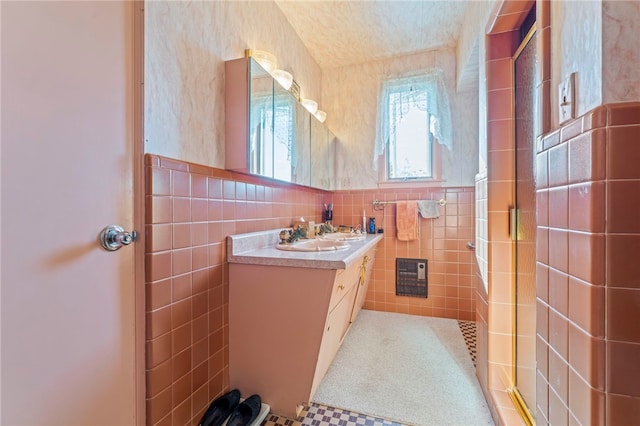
[{"x1": 145, "y1": 155, "x2": 477, "y2": 425}]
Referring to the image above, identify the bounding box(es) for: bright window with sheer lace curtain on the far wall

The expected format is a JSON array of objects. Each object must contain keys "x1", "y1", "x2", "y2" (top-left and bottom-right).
[{"x1": 375, "y1": 71, "x2": 451, "y2": 181}]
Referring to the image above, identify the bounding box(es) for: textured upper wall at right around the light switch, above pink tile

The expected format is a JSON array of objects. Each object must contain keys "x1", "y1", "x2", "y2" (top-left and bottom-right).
[{"x1": 551, "y1": 0, "x2": 640, "y2": 129}]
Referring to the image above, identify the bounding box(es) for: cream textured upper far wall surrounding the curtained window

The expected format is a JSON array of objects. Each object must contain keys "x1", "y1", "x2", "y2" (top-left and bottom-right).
[{"x1": 322, "y1": 48, "x2": 478, "y2": 189}]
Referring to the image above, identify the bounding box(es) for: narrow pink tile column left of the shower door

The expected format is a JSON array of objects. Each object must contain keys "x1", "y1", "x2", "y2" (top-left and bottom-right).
[{"x1": 476, "y1": 25, "x2": 525, "y2": 424}]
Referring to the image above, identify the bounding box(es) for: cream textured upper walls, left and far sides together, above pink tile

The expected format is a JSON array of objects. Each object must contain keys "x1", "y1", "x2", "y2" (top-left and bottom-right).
[{"x1": 145, "y1": 1, "x2": 478, "y2": 189}]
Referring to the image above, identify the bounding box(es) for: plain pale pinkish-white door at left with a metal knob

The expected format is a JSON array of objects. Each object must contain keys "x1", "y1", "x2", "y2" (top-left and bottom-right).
[{"x1": 0, "y1": 1, "x2": 144, "y2": 426}]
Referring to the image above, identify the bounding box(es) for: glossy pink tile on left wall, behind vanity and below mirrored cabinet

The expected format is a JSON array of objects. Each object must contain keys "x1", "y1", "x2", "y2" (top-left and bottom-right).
[{"x1": 145, "y1": 155, "x2": 323, "y2": 425}]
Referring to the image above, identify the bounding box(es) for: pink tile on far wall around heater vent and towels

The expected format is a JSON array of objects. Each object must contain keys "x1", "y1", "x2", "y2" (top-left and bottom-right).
[{"x1": 325, "y1": 187, "x2": 477, "y2": 321}]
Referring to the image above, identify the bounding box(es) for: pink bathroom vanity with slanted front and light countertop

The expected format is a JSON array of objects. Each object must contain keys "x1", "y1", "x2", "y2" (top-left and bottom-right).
[{"x1": 227, "y1": 230, "x2": 382, "y2": 419}]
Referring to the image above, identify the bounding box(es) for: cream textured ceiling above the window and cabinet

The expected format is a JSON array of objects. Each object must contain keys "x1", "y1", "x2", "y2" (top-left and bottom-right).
[{"x1": 275, "y1": 0, "x2": 467, "y2": 68}]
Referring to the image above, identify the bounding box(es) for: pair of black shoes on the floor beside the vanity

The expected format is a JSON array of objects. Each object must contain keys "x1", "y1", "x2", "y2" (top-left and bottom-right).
[{"x1": 199, "y1": 389, "x2": 262, "y2": 426}]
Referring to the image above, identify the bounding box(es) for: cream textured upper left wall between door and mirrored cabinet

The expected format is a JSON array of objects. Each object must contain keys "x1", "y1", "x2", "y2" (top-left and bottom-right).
[{"x1": 145, "y1": 1, "x2": 321, "y2": 168}]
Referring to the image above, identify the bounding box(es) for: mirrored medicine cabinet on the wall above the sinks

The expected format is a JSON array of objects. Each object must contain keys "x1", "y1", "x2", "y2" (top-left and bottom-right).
[{"x1": 225, "y1": 57, "x2": 335, "y2": 190}]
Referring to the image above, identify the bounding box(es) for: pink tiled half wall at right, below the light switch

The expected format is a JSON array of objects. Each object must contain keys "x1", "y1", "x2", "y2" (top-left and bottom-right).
[{"x1": 537, "y1": 103, "x2": 640, "y2": 425}]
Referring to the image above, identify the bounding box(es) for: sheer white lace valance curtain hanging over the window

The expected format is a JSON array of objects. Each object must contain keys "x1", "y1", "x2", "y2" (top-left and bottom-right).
[{"x1": 373, "y1": 69, "x2": 453, "y2": 167}]
